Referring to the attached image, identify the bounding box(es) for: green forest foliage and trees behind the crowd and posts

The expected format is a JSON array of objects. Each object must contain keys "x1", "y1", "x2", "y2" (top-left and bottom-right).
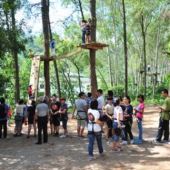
[{"x1": 0, "y1": 0, "x2": 170, "y2": 109}]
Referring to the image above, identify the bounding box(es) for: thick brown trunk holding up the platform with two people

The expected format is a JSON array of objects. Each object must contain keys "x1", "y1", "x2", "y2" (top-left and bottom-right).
[{"x1": 90, "y1": 0, "x2": 97, "y2": 99}]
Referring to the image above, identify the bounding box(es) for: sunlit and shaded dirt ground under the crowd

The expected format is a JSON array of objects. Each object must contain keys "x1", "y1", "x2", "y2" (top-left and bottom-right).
[{"x1": 0, "y1": 107, "x2": 170, "y2": 170}]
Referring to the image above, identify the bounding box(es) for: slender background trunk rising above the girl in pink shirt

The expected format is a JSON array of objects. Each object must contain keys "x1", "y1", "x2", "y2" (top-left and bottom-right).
[{"x1": 141, "y1": 14, "x2": 147, "y2": 97}]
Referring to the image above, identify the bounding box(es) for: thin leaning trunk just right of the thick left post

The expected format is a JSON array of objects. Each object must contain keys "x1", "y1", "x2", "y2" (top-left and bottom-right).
[{"x1": 49, "y1": 20, "x2": 61, "y2": 99}]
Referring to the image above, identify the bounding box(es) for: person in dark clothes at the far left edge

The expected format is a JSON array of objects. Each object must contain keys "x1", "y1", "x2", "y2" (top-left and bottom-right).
[{"x1": 0, "y1": 98, "x2": 9, "y2": 139}]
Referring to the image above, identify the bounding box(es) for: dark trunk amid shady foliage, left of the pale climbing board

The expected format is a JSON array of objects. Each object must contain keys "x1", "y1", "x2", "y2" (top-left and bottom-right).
[{"x1": 11, "y1": 8, "x2": 20, "y2": 102}]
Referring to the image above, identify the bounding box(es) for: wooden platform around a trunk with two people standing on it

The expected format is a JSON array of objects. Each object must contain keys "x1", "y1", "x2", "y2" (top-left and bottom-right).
[{"x1": 77, "y1": 42, "x2": 109, "y2": 50}]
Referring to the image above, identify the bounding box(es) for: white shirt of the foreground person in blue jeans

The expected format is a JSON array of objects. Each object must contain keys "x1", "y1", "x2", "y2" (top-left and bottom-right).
[{"x1": 88, "y1": 109, "x2": 101, "y2": 132}]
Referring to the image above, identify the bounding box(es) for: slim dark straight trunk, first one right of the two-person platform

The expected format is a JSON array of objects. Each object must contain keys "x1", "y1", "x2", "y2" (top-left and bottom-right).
[{"x1": 122, "y1": 0, "x2": 128, "y2": 96}]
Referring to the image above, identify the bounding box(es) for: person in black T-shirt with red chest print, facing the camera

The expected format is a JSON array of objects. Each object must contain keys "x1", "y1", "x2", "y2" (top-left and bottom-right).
[{"x1": 51, "y1": 94, "x2": 61, "y2": 137}]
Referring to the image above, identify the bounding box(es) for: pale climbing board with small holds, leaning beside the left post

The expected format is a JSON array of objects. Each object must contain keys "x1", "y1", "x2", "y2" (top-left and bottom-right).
[{"x1": 30, "y1": 56, "x2": 40, "y2": 100}]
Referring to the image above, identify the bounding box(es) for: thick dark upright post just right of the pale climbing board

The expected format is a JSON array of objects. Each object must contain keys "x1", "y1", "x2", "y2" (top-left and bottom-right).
[{"x1": 41, "y1": 0, "x2": 50, "y2": 96}]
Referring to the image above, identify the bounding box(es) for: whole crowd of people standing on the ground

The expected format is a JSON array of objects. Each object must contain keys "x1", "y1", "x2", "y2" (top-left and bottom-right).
[{"x1": 0, "y1": 89, "x2": 170, "y2": 160}]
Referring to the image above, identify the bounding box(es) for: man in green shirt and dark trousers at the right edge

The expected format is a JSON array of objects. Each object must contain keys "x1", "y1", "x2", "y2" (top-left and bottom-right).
[{"x1": 152, "y1": 89, "x2": 170, "y2": 143}]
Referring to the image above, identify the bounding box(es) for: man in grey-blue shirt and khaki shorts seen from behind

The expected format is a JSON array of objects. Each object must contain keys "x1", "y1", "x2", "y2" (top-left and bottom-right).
[{"x1": 72, "y1": 92, "x2": 87, "y2": 138}]
